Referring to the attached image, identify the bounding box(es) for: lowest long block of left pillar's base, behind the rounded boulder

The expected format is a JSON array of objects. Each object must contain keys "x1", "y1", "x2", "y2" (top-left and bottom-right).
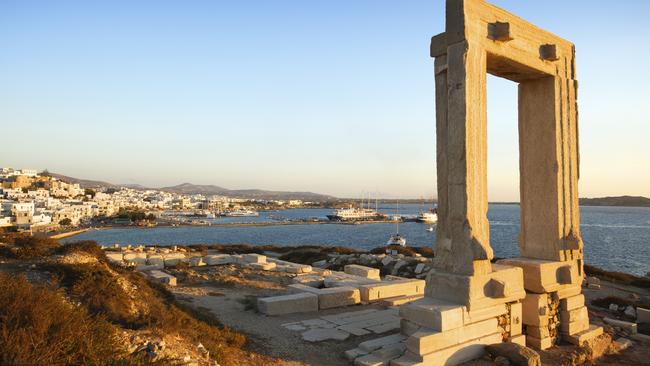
[{"x1": 409, "y1": 333, "x2": 501, "y2": 366}]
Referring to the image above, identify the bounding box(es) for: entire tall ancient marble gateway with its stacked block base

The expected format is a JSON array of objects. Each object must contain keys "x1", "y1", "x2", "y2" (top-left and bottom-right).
[{"x1": 391, "y1": 0, "x2": 602, "y2": 365}]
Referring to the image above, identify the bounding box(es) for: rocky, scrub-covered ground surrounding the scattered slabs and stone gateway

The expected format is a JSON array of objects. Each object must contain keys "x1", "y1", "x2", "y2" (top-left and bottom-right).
[{"x1": 0, "y1": 236, "x2": 650, "y2": 365}]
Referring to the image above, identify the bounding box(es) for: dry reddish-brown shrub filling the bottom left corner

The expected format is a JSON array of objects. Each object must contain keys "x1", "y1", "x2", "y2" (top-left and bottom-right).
[{"x1": 0, "y1": 273, "x2": 128, "y2": 365}]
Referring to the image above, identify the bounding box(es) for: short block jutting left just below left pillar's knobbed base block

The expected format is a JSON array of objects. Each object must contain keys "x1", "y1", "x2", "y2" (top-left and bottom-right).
[{"x1": 399, "y1": 297, "x2": 464, "y2": 332}]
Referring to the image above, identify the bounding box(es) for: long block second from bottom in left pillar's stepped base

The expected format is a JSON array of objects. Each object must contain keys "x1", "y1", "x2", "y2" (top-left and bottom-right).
[{"x1": 406, "y1": 318, "x2": 498, "y2": 355}]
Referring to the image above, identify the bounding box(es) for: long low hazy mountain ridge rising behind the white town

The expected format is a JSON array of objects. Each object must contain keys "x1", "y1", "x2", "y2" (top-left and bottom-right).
[{"x1": 49, "y1": 173, "x2": 336, "y2": 201}]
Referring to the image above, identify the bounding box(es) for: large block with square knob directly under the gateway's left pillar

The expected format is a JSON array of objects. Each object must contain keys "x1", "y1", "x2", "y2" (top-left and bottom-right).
[{"x1": 426, "y1": 264, "x2": 526, "y2": 310}]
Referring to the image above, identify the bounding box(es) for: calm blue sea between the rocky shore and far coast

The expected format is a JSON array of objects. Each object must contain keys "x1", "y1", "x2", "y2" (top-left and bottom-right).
[{"x1": 67, "y1": 204, "x2": 650, "y2": 275}]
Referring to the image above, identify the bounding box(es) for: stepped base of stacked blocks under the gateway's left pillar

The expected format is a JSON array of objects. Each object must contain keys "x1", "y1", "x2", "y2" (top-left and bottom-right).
[{"x1": 391, "y1": 265, "x2": 526, "y2": 366}]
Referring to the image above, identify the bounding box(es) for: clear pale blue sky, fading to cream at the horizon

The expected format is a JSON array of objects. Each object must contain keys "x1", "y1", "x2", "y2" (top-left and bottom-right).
[{"x1": 0, "y1": 0, "x2": 650, "y2": 201}]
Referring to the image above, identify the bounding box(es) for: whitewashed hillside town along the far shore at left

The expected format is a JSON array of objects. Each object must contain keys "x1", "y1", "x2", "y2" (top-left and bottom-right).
[{"x1": 0, "y1": 168, "x2": 303, "y2": 233}]
